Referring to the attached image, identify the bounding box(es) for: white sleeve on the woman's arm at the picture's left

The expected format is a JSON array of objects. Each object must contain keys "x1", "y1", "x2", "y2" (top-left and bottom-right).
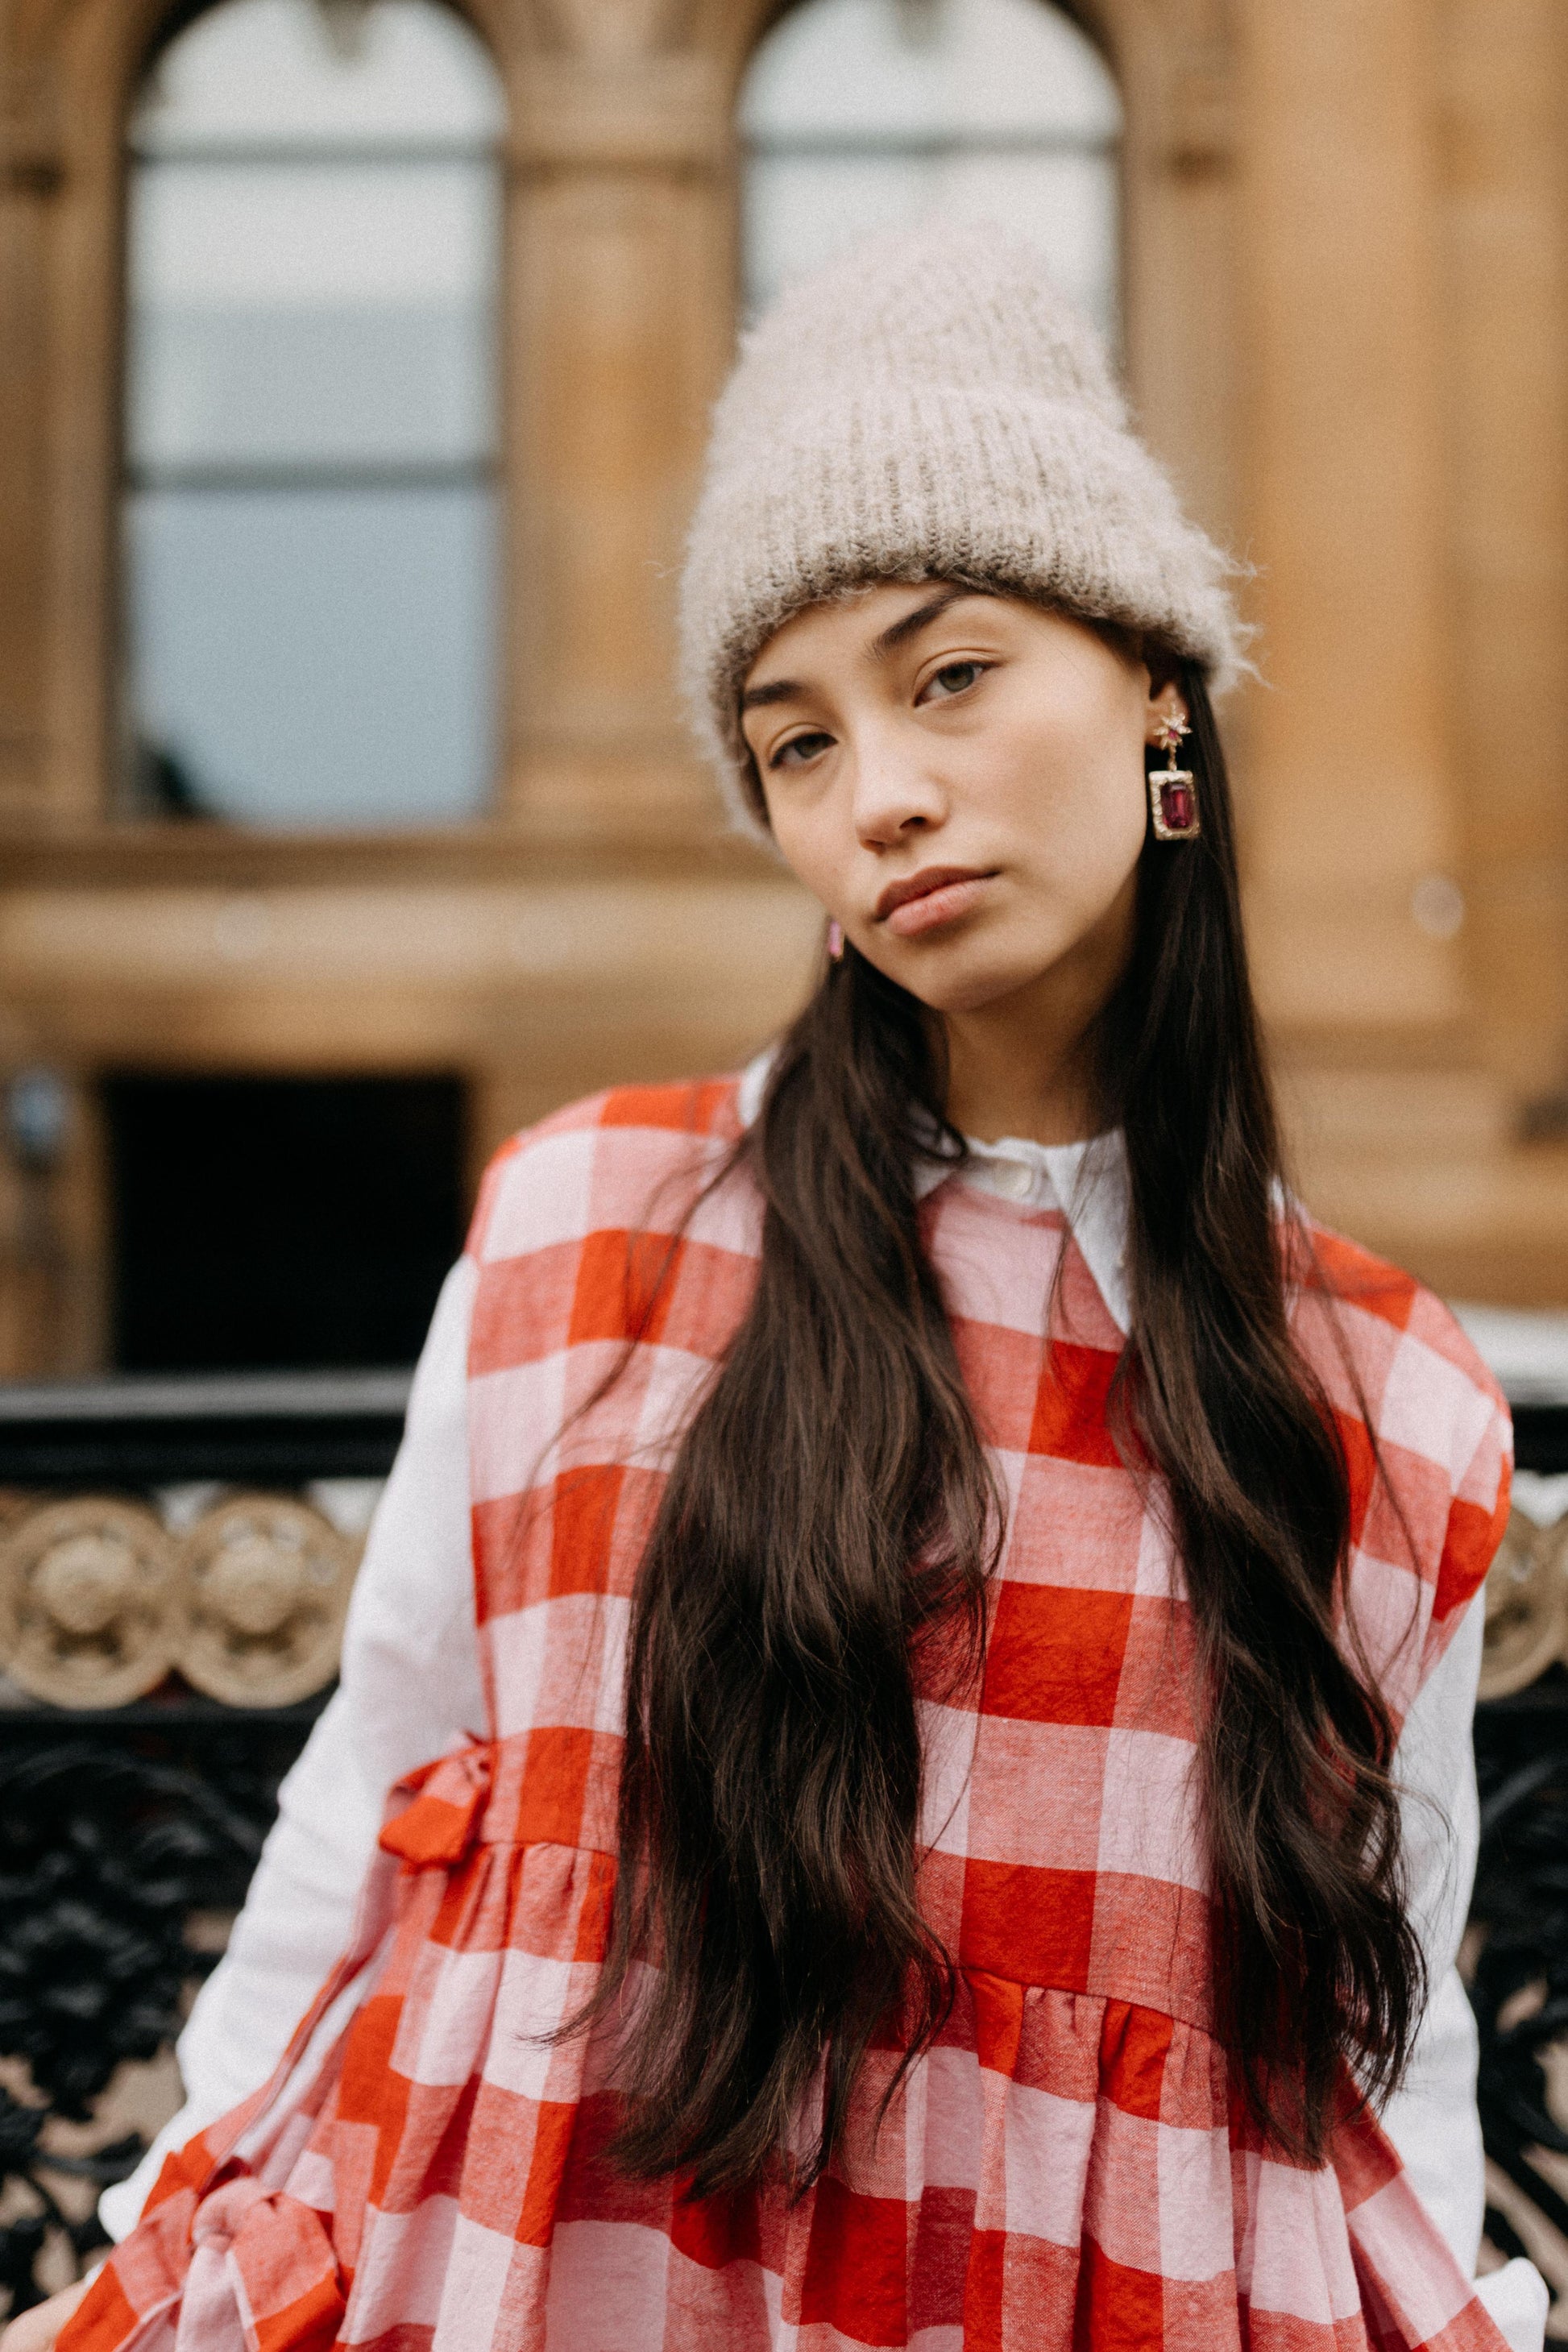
[{"x1": 99, "y1": 1259, "x2": 484, "y2": 2239}]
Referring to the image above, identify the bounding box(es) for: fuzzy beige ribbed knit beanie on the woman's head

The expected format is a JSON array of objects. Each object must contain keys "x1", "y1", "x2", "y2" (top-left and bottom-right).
[{"x1": 682, "y1": 221, "x2": 1243, "y2": 837}]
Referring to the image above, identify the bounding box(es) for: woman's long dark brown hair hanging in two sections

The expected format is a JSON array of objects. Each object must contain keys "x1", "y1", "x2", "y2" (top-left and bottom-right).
[{"x1": 590, "y1": 663, "x2": 1422, "y2": 2194}]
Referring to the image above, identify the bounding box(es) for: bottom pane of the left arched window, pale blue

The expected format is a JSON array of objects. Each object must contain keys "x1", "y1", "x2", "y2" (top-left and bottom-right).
[{"x1": 127, "y1": 482, "x2": 494, "y2": 826}]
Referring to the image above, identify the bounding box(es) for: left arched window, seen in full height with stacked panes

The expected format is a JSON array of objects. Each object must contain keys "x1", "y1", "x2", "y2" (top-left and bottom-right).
[{"x1": 122, "y1": 0, "x2": 503, "y2": 828}]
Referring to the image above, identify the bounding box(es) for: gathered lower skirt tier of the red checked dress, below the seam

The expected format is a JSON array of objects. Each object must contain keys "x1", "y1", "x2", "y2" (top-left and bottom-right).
[{"x1": 97, "y1": 1750, "x2": 1497, "y2": 2352}]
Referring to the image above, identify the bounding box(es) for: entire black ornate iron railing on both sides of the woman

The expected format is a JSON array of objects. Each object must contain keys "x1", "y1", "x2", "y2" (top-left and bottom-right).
[{"x1": 0, "y1": 1371, "x2": 1568, "y2": 2309}]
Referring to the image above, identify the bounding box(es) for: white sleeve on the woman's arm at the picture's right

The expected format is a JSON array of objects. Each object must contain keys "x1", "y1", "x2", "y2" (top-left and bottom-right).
[{"x1": 1383, "y1": 1592, "x2": 1547, "y2": 2352}]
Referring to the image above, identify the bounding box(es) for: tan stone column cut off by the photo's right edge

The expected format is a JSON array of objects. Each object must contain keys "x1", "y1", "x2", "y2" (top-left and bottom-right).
[{"x1": 1439, "y1": 0, "x2": 1568, "y2": 1093}]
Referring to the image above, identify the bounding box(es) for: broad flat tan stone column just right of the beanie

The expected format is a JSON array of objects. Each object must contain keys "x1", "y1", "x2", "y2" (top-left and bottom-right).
[{"x1": 1237, "y1": 0, "x2": 1465, "y2": 1049}]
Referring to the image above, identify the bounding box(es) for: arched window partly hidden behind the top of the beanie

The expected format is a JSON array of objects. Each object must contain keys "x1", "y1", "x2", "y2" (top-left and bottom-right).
[{"x1": 740, "y1": 0, "x2": 1122, "y2": 336}]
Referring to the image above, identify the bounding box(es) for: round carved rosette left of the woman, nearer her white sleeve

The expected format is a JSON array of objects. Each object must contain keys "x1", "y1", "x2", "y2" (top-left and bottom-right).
[{"x1": 179, "y1": 1494, "x2": 359, "y2": 1707}]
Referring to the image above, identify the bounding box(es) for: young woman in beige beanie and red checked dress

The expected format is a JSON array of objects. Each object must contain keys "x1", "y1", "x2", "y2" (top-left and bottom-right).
[{"x1": 12, "y1": 230, "x2": 1545, "y2": 2352}]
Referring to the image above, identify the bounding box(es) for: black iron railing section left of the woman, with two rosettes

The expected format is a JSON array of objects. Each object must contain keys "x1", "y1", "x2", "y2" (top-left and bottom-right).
[{"x1": 0, "y1": 1371, "x2": 409, "y2": 2309}]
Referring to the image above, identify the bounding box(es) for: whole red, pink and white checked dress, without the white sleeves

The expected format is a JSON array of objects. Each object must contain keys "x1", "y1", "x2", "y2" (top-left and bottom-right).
[{"x1": 59, "y1": 1082, "x2": 1509, "y2": 2352}]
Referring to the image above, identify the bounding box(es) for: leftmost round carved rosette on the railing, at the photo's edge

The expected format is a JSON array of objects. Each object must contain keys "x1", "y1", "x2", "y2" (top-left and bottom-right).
[{"x1": 0, "y1": 1495, "x2": 184, "y2": 1707}]
